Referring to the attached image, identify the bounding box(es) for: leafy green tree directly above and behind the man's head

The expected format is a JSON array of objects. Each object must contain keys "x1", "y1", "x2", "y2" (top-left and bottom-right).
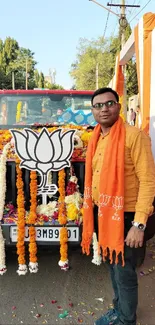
[{"x1": 70, "y1": 37, "x2": 119, "y2": 90}]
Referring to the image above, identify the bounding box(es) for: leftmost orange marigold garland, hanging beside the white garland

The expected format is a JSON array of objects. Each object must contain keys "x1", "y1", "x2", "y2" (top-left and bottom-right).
[{"x1": 16, "y1": 160, "x2": 27, "y2": 275}]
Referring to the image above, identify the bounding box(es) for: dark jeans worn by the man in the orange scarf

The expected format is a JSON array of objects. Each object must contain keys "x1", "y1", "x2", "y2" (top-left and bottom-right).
[{"x1": 94, "y1": 207, "x2": 146, "y2": 325}]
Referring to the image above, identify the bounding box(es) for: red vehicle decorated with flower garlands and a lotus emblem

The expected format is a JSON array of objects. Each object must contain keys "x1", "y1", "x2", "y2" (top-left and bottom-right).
[{"x1": 0, "y1": 90, "x2": 93, "y2": 245}]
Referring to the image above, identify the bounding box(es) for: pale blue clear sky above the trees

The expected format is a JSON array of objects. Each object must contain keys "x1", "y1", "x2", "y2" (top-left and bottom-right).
[{"x1": 0, "y1": 0, "x2": 155, "y2": 89}]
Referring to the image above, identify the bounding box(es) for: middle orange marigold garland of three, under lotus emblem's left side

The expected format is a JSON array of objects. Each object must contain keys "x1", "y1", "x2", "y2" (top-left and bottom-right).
[{"x1": 28, "y1": 171, "x2": 38, "y2": 273}]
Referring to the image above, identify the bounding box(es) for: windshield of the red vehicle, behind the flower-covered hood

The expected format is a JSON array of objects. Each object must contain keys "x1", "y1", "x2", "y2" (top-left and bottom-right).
[{"x1": 0, "y1": 93, "x2": 91, "y2": 125}]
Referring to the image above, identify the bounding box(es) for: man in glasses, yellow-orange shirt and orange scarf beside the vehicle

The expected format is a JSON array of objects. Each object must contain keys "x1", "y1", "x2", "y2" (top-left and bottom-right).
[{"x1": 82, "y1": 88, "x2": 155, "y2": 325}]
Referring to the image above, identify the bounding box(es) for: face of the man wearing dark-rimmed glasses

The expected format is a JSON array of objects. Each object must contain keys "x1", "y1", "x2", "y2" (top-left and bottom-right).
[{"x1": 92, "y1": 92, "x2": 121, "y2": 127}]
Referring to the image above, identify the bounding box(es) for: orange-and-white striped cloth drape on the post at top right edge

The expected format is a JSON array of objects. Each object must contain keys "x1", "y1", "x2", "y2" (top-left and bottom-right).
[{"x1": 134, "y1": 13, "x2": 155, "y2": 131}]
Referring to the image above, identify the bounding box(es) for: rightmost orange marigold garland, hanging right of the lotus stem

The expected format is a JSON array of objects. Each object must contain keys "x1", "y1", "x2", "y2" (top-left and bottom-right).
[{"x1": 58, "y1": 169, "x2": 69, "y2": 271}]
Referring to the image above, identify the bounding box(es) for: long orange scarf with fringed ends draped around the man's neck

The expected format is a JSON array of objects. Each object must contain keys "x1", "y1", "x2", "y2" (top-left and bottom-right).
[{"x1": 81, "y1": 117, "x2": 125, "y2": 265}]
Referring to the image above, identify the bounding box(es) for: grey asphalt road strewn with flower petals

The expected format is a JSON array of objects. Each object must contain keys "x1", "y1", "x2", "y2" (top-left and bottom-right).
[{"x1": 0, "y1": 243, "x2": 155, "y2": 325}]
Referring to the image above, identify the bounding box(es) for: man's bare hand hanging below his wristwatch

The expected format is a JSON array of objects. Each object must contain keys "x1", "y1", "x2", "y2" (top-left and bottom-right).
[{"x1": 125, "y1": 226, "x2": 144, "y2": 248}]
